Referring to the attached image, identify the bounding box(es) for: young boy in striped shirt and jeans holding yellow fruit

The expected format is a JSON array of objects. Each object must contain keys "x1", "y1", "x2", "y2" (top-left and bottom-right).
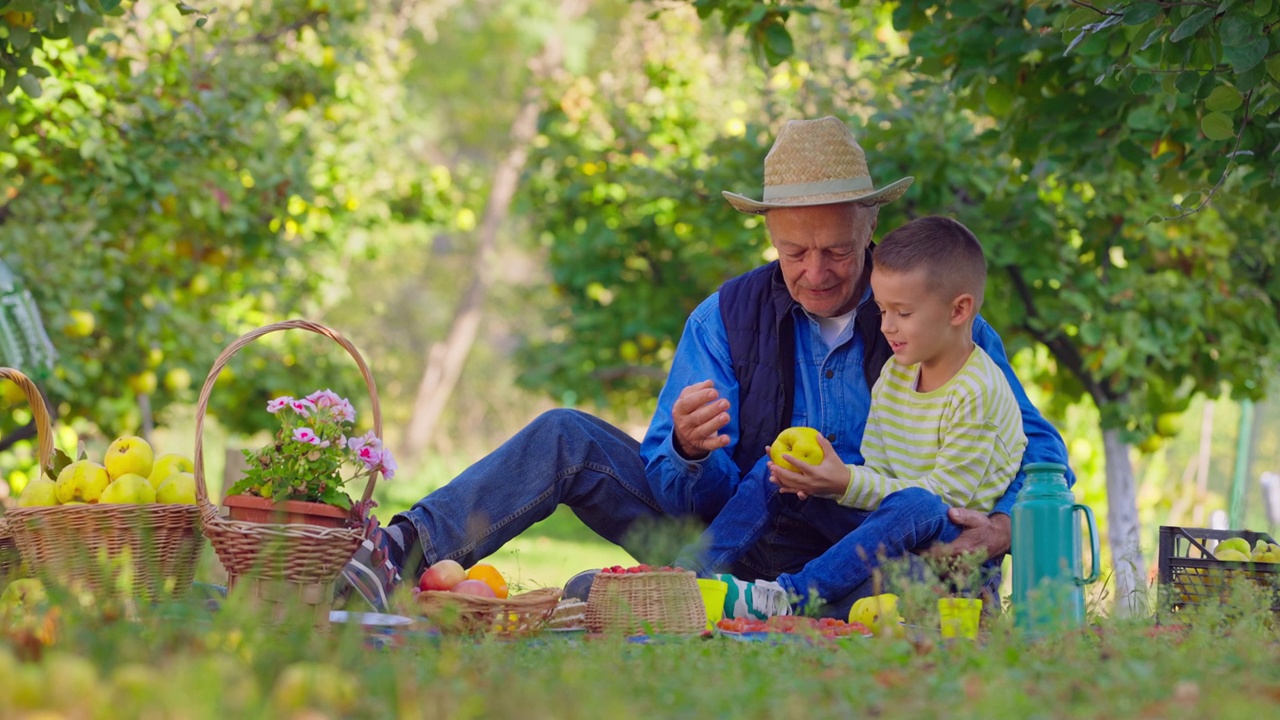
[{"x1": 676, "y1": 217, "x2": 1027, "y2": 618}]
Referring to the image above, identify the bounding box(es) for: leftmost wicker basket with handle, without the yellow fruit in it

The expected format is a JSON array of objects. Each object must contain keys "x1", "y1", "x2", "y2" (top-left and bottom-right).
[{"x1": 0, "y1": 368, "x2": 202, "y2": 600}]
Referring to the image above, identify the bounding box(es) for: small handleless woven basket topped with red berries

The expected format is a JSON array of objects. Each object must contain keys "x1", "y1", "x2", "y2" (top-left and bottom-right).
[{"x1": 586, "y1": 570, "x2": 707, "y2": 634}]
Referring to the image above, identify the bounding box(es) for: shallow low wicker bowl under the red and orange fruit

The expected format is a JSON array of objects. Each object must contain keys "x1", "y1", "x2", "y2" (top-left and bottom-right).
[{"x1": 417, "y1": 588, "x2": 561, "y2": 637}]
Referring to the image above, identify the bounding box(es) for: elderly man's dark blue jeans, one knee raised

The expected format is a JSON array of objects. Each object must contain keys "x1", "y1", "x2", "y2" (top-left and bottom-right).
[{"x1": 392, "y1": 410, "x2": 998, "y2": 616}]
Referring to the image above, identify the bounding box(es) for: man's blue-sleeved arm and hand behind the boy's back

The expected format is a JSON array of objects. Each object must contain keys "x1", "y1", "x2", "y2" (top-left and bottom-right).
[{"x1": 946, "y1": 315, "x2": 1075, "y2": 557}]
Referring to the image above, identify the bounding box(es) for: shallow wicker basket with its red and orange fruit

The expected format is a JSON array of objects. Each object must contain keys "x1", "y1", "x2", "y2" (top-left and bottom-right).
[{"x1": 413, "y1": 560, "x2": 561, "y2": 637}]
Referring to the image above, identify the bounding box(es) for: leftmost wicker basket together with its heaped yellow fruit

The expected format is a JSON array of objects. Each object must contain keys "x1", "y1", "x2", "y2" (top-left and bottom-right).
[{"x1": 0, "y1": 368, "x2": 204, "y2": 600}]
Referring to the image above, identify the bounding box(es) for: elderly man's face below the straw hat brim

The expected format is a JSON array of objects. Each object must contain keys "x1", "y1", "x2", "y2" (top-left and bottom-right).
[{"x1": 764, "y1": 202, "x2": 878, "y2": 318}]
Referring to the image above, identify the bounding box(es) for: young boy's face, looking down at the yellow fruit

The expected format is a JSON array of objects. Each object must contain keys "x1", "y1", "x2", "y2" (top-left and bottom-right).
[{"x1": 872, "y1": 268, "x2": 965, "y2": 365}]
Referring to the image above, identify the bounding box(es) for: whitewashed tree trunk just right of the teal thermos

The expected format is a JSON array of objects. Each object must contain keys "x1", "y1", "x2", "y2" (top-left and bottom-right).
[{"x1": 1102, "y1": 429, "x2": 1148, "y2": 616}]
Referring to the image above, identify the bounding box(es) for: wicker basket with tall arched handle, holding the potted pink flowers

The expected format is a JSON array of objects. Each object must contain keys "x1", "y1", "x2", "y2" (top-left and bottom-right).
[{"x1": 195, "y1": 320, "x2": 383, "y2": 629}]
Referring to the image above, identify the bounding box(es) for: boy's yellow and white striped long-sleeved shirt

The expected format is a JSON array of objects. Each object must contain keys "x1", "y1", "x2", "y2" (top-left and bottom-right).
[{"x1": 840, "y1": 347, "x2": 1027, "y2": 512}]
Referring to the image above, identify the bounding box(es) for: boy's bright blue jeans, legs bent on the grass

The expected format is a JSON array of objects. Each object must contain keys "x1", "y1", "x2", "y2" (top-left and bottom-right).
[{"x1": 677, "y1": 478, "x2": 960, "y2": 605}]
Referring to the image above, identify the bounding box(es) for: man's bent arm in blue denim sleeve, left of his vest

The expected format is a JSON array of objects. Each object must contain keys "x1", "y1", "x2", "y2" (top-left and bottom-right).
[{"x1": 640, "y1": 293, "x2": 739, "y2": 516}]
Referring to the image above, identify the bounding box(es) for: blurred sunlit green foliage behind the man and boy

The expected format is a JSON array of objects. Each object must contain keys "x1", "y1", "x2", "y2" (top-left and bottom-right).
[{"x1": 0, "y1": 0, "x2": 1280, "y2": 599}]
